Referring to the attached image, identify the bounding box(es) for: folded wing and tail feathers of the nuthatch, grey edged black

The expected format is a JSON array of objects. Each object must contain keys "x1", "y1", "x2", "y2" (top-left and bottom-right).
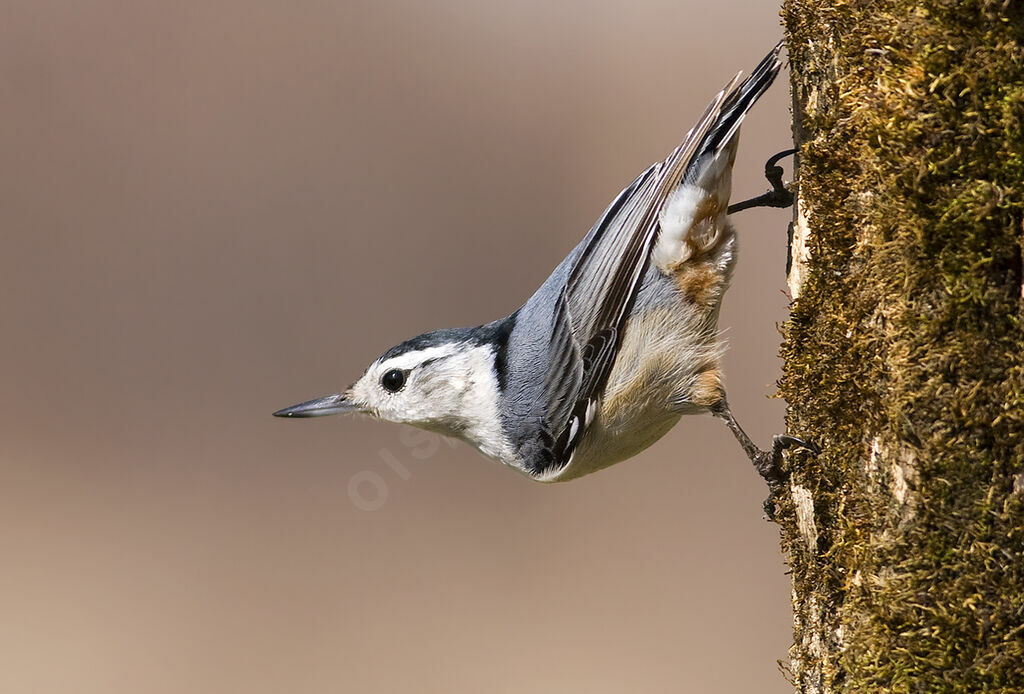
[{"x1": 536, "y1": 47, "x2": 780, "y2": 474}]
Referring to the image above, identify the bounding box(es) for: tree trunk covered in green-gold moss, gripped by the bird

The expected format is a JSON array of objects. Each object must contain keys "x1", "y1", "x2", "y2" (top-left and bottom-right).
[{"x1": 774, "y1": 0, "x2": 1024, "y2": 694}]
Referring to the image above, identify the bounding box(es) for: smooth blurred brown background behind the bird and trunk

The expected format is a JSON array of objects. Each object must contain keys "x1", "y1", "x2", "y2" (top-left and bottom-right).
[{"x1": 0, "y1": 0, "x2": 791, "y2": 694}]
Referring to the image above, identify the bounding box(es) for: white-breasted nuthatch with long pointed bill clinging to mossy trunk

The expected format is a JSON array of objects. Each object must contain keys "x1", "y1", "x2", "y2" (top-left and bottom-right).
[{"x1": 273, "y1": 42, "x2": 810, "y2": 485}]
